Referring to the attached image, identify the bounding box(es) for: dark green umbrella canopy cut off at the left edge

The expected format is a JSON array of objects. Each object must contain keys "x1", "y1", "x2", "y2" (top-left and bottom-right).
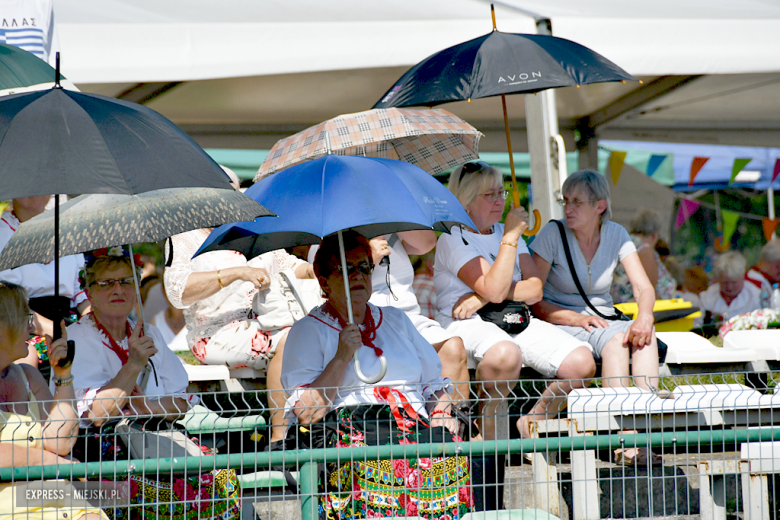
[{"x1": 0, "y1": 43, "x2": 77, "y2": 96}]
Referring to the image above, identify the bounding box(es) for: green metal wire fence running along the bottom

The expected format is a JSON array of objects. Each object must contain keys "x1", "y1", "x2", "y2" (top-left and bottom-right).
[{"x1": 0, "y1": 373, "x2": 780, "y2": 520}]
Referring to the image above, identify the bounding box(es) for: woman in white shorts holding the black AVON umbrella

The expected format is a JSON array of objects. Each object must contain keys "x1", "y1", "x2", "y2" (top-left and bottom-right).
[{"x1": 433, "y1": 161, "x2": 596, "y2": 439}]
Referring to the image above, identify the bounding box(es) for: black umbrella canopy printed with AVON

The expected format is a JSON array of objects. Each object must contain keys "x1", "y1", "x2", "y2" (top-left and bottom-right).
[{"x1": 374, "y1": 31, "x2": 636, "y2": 108}]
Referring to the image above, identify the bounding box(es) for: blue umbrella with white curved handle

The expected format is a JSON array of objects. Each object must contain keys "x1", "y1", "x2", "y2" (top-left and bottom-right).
[{"x1": 196, "y1": 155, "x2": 476, "y2": 383}]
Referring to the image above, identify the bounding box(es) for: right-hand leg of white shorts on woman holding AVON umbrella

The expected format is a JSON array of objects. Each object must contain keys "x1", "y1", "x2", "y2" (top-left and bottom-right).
[{"x1": 514, "y1": 318, "x2": 592, "y2": 378}]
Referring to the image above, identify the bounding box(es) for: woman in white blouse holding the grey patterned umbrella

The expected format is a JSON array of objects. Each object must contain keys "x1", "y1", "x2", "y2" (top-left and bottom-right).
[{"x1": 68, "y1": 247, "x2": 241, "y2": 520}]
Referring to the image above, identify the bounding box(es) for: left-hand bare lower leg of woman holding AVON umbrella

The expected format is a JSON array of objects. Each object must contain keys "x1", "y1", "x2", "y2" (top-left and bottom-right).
[{"x1": 477, "y1": 341, "x2": 523, "y2": 440}]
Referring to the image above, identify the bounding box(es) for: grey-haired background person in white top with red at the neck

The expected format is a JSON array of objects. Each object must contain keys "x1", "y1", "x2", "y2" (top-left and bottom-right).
[{"x1": 699, "y1": 251, "x2": 761, "y2": 321}]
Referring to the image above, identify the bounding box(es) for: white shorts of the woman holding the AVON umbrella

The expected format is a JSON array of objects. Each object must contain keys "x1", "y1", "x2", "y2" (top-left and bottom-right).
[{"x1": 436, "y1": 314, "x2": 590, "y2": 378}]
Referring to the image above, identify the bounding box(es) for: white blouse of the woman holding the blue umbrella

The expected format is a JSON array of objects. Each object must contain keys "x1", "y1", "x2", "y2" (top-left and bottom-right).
[{"x1": 282, "y1": 303, "x2": 450, "y2": 417}]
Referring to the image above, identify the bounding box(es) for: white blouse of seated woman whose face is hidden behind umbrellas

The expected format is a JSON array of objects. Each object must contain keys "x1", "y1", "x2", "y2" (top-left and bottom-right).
[{"x1": 165, "y1": 229, "x2": 305, "y2": 347}]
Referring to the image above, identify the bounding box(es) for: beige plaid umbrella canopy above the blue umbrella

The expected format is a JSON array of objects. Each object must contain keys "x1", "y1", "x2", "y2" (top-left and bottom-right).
[{"x1": 255, "y1": 108, "x2": 482, "y2": 182}]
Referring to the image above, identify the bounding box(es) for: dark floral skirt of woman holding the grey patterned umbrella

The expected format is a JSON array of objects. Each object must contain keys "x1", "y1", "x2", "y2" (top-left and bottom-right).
[{"x1": 73, "y1": 424, "x2": 241, "y2": 520}]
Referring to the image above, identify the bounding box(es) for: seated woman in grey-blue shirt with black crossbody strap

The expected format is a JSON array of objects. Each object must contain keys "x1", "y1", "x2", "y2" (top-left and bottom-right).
[{"x1": 531, "y1": 170, "x2": 658, "y2": 464}]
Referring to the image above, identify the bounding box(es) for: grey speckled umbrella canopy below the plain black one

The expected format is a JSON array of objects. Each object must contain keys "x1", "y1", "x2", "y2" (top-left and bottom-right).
[{"x1": 0, "y1": 188, "x2": 273, "y2": 270}]
